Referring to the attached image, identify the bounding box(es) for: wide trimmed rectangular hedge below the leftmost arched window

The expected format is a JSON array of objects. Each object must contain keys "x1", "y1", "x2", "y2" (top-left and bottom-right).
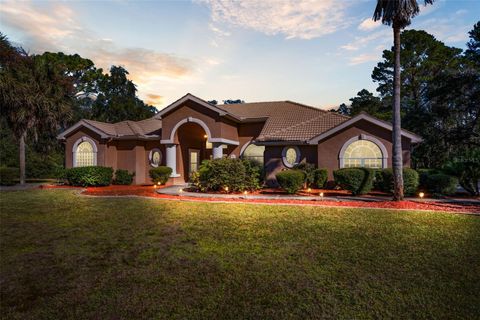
[{"x1": 66, "y1": 166, "x2": 113, "y2": 187}]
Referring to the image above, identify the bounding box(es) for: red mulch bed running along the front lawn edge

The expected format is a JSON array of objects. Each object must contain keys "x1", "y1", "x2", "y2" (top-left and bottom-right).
[{"x1": 38, "y1": 185, "x2": 480, "y2": 213}]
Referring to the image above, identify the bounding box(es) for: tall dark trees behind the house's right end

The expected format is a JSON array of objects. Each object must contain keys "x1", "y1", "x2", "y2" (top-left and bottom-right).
[{"x1": 333, "y1": 22, "x2": 480, "y2": 172}]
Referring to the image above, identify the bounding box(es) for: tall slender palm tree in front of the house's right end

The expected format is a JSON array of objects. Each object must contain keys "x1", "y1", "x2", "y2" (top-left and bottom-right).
[{"x1": 373, "y1": 0, "x2": 434, "y2": 201}]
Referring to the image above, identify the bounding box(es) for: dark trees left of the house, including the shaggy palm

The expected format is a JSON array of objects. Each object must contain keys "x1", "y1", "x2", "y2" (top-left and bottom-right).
[{"x1": 0, "y1": 33, "x2": 156, "y2": 183}]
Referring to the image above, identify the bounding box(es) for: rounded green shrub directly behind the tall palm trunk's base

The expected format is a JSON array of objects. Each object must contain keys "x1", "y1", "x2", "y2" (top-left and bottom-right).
[{"x1": 374, "y1": 168, "x2": 419, "y2": 195}]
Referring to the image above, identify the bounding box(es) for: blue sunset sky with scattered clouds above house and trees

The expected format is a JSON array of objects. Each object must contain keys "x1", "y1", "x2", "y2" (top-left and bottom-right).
[{"x1": 0, "y1": 0, "x2": 480, "y2": 110}]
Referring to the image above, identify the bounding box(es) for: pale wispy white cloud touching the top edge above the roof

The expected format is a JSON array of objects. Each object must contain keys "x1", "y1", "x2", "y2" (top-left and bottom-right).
[{"x1": 199, "y1": 0, "x2": 348, "y2": 39}]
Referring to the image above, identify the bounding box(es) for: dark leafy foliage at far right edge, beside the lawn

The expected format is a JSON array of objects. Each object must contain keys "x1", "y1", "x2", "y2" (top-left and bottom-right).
[{"x1": 443, "y1": 148, "x2": 480, "y2": 196}]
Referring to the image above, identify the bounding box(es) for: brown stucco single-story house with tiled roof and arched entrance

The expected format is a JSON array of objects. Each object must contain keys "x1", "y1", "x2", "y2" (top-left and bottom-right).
[{"x1": 58, "y1": 94, "x2": 421, "y2": 185}]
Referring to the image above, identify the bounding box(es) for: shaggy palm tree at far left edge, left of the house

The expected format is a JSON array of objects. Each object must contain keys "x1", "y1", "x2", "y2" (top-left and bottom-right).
[{"x1": 0, "y1": 33, "x2": 72, "y2": 184}]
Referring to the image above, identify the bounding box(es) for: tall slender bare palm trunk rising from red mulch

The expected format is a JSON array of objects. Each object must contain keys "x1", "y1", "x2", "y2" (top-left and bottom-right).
[{"x1": 392, "y1": 23, "x2": 403, "y2": 201}]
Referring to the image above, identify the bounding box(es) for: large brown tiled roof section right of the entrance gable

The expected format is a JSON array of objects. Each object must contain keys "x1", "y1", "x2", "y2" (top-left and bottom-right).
[{"x1": 218, "y1": 101, "x2": 349, "y2": 141}]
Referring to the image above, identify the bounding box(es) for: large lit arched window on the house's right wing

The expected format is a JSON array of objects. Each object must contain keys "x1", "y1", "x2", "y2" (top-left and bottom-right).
[{"x1": 340, "y1": 140, "x2": 384, "y2": 168}]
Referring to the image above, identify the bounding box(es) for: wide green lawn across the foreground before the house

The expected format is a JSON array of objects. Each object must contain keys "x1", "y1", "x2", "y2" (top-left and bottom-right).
[{"x1": 0, "y1": 190, "x2": 480, "y2": 319}]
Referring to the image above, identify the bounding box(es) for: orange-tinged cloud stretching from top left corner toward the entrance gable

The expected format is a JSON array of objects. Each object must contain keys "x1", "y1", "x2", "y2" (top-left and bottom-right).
[{"x1": 0, "y1": 2, "x2": 196, "y2": 108}]
